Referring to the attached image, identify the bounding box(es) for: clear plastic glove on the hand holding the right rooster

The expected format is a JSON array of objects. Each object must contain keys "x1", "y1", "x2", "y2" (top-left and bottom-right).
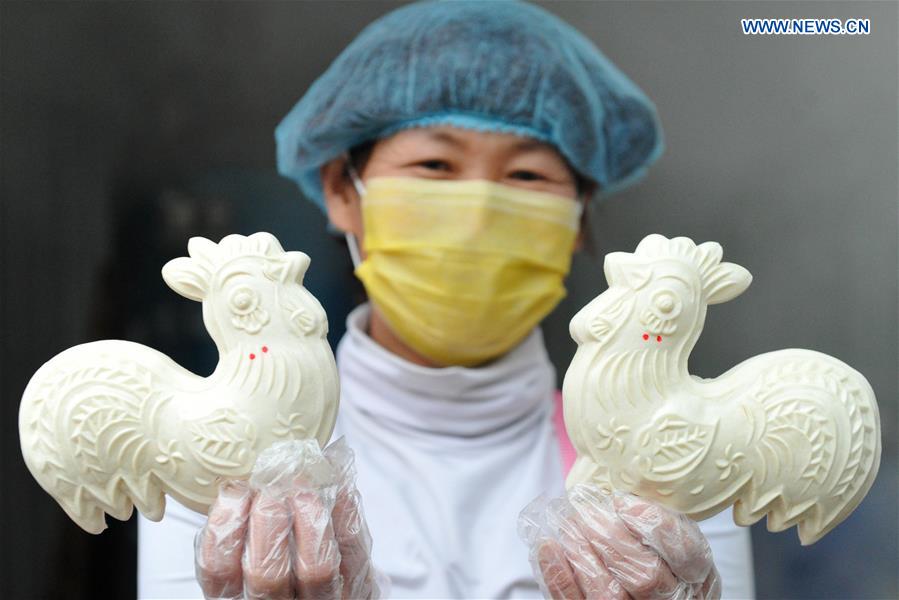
[{"x1": 518, "y1": 484, "x2": 721, "y2": 600}]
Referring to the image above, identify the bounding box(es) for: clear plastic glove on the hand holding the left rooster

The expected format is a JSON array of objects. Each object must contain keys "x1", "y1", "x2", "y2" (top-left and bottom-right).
[{"x1": 194, "y1": 438, "x2": 383, "y2": 600}]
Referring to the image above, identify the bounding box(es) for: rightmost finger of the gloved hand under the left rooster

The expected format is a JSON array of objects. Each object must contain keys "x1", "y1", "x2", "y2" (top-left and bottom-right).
[{"x1": 331, "y1": 485, "x2": 374, "y2": 598}]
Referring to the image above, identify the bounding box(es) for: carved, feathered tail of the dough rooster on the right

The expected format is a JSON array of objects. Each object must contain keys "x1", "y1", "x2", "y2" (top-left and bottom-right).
[{"x1": 734, "y1": 350, "x2": 880, "y2": 545}]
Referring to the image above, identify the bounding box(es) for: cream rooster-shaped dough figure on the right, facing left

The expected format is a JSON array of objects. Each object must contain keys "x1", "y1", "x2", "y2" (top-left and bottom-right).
[{"x1": 563, "y1": 235, "x2": 880, "y2": 545}]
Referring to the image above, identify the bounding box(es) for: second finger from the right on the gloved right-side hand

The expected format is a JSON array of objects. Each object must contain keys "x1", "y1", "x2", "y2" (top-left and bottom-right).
[{"x1": 572, "y1": 487, "x2": 679, "y2": 600}]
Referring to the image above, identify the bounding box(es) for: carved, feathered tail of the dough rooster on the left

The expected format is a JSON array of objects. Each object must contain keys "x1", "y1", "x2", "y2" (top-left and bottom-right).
[{"x1": 19, "y1": 340, "x2": 164, "y2": 534}]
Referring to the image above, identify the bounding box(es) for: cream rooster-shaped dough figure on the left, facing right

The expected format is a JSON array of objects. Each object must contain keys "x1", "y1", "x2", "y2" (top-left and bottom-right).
[{"x1": 19, "y1": 233, "x2": 338, "y2": 533}]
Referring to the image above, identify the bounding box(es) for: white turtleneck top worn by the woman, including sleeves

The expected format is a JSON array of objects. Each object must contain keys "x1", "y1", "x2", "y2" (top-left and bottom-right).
[{"x1": 138, "y1": 303, "x2": 754, "y2": 599}]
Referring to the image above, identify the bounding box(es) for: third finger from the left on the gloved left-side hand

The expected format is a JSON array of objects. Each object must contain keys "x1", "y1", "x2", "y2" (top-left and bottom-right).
[{"x1": 290, "y1": 490, "x2": 342, "y2": 599}]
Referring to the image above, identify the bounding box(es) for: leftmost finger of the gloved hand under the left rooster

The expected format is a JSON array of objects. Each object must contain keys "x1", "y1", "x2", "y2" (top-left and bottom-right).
[{"x1": 195, "y1": 481, "x2": 253, "y2": 598}]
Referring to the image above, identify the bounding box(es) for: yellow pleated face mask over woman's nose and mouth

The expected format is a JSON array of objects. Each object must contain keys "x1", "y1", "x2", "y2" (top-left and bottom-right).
[{"x1": 351, "y1": 170, "x2": 582, "y2": 366}]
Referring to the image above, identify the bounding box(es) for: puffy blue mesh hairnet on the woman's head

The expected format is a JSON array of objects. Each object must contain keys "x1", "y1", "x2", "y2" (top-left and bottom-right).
[{"x1": 275, "y1": 0, "x2": 663, "y2": 210}]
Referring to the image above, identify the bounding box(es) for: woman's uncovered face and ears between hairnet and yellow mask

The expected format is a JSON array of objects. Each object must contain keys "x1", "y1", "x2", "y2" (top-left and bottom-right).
[{"x1": 321, "y1": 126, "x2": 595, "y2": 258}]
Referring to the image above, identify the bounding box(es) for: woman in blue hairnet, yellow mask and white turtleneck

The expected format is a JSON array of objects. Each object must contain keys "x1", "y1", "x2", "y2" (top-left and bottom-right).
[{"x1": 139, "y1": 2, "x2": 753, "y2": 598}]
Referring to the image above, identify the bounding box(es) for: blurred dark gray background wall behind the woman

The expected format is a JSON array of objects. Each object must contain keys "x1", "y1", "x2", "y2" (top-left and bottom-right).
[{"x1": 0, "y1": 2, "x2": 899, "y2": 598}]
